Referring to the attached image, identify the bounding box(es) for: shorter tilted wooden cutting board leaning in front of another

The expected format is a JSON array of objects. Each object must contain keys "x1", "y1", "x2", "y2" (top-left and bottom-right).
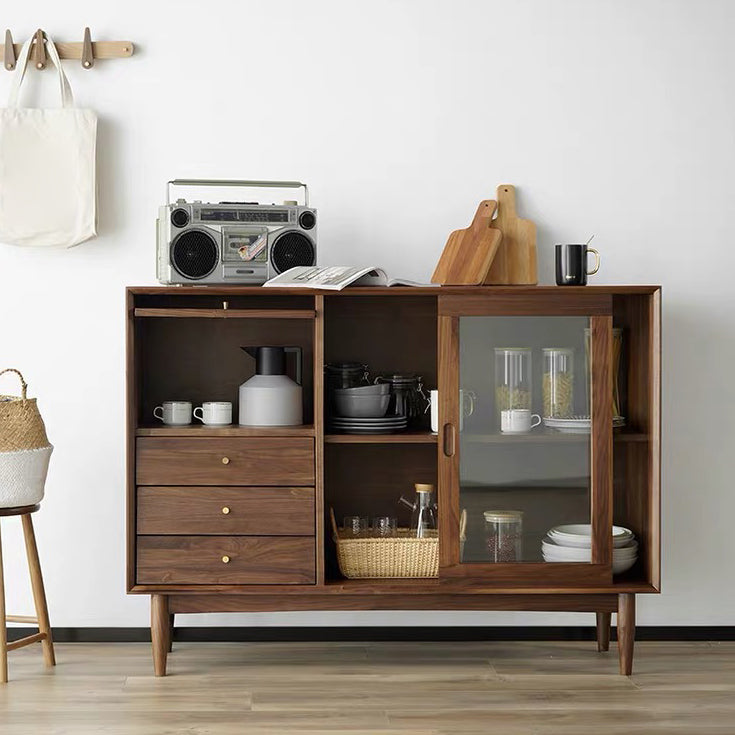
[{"x1": 431, "y1": 199, "x2": 503, "y2": 286}]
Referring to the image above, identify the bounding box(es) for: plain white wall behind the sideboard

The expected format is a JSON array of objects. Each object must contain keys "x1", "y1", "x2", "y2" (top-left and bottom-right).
[{"x1": 0, "y1": 0, "x2": 735, "y2": 626}]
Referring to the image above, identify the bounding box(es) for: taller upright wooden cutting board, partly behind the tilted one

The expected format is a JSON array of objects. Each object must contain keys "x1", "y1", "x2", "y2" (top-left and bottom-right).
[{"x1": 484, "y1": 184, "x2": 538, "y2": 286}]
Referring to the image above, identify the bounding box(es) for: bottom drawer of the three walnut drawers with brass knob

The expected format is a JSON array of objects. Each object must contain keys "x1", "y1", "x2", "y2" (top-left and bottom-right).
[{"x1": 137, "y1": 536, "x2": 316, "y2": 584}]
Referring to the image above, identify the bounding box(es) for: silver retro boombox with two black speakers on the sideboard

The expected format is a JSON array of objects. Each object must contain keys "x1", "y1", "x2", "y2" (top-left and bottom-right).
[{"x1": 157, "y1": 179, "x2": 316, "y2": 286}]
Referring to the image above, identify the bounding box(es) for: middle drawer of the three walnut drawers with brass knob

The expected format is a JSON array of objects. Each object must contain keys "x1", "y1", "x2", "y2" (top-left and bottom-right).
[{"x1": 137, "y1": 487, "x2": 314, "y2": 536}]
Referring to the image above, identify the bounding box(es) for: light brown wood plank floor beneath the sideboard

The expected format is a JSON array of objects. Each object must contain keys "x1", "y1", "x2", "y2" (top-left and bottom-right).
[{"x1": 0, "y1": 643, "x2": 735, "y2": 735}]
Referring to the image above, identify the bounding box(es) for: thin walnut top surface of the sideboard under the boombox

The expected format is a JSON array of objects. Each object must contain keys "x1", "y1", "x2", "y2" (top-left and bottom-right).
[{"x1": 127, "y1": 285, "x2": 661, "y2": 296}]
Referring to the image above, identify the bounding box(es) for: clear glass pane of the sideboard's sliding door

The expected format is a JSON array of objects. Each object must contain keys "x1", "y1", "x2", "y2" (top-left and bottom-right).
[{"x1": 459, "y1": 316, "x2": 592, "y2": 564}]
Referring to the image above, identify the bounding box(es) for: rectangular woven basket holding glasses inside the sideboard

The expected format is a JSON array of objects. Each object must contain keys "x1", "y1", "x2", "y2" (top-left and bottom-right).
[{"x1": 329, "y1": 508, "x2": 439, "y2": 579}]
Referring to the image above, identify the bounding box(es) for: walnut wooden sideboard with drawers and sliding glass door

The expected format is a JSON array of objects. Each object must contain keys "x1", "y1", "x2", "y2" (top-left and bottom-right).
[{"x1": 126, "y1": 286, "x2": 661, "y2": 676}]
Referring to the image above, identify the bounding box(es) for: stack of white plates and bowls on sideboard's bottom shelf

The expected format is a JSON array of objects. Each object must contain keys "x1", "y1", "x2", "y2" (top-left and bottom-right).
[{"x1": 541, "y1": 523, "x2": 638, "y2": 574}]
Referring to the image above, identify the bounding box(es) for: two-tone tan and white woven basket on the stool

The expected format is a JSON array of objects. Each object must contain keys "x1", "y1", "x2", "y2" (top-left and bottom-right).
[{"x1": 0, "y1": 368, "x2": 53, "y2": 508}]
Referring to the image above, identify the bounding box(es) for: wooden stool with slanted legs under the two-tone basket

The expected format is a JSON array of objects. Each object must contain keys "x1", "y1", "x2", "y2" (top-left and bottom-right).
[{"x1": 0, "y1": 505, "x2": 56, "y2": 684}]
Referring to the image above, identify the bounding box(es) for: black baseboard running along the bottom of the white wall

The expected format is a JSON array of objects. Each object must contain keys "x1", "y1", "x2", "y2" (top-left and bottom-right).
[{"x1": 8, "y1": 625, "x2": 735, "y2": 643}]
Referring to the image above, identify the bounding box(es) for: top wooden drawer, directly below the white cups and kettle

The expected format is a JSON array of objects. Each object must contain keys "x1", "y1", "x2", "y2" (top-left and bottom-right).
[{"x1": 136, "y1": 437, "x2": 314, "y2": 485}]
